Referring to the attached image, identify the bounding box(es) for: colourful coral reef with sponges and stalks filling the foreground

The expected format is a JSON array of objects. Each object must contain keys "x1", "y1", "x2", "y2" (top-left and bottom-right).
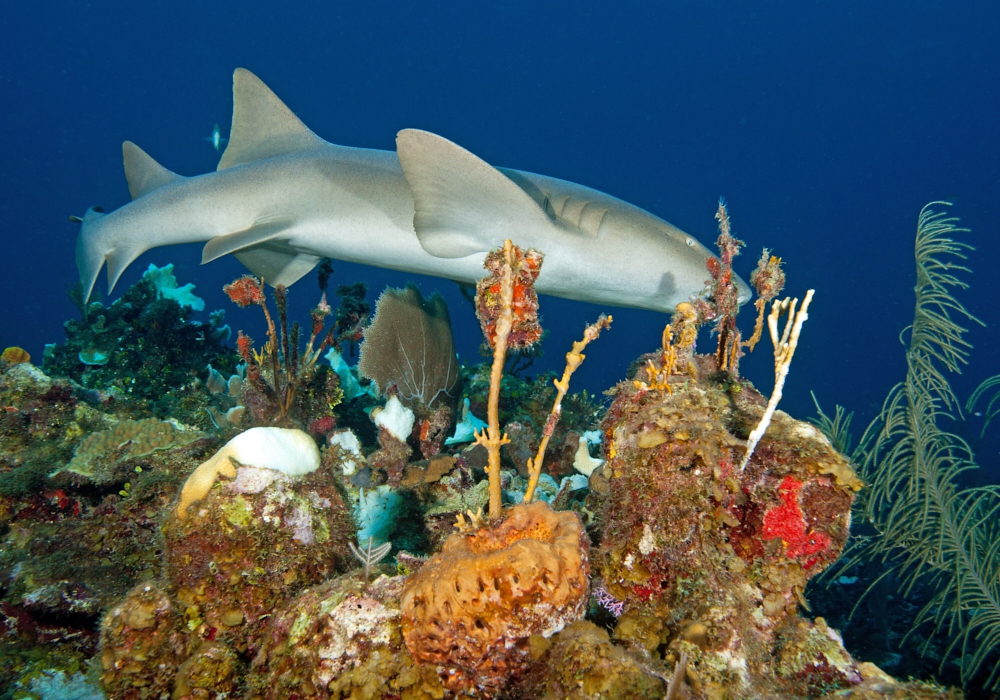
[{"x1": 0, "y1": 207, "x2": 972, "y2": 700}]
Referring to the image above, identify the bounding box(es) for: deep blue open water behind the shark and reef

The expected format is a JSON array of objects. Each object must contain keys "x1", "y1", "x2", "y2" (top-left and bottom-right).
[{"x1": 0, "y1": 0, "x2": 1000, "y2": 468}]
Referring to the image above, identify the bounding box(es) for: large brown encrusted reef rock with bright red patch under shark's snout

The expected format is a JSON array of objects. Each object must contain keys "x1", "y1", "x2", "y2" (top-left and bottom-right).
[{"x1": 591, "y1": 358, "x2": 862, "y2": 698}]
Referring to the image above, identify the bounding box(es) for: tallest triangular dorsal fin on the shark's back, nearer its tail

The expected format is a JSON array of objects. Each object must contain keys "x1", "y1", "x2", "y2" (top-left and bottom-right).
[{"x1": 217, "y1": 68, "x2": 326, "y2": 170}]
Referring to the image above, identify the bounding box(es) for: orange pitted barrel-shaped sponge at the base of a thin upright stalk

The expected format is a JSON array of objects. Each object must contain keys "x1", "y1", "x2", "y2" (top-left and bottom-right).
[{"x1": 402, "y1": 501, "x2": 590, "y2": 697}]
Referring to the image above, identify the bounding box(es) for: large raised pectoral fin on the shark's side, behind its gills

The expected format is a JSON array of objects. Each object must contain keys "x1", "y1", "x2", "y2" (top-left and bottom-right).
[{"x1": 396, "y1": 129, "x2": 553, "y2": 258}]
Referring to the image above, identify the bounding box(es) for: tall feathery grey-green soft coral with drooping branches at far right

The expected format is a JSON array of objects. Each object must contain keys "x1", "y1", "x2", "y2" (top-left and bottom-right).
[{"x1": 844, "y1": 202, "x2": 1000, "y2": 690}]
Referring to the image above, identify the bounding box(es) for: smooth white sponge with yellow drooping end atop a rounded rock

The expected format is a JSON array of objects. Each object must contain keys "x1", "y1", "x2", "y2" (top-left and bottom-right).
[{"x1": 177, "y1": 428, "x2": 319, "y2": 520}]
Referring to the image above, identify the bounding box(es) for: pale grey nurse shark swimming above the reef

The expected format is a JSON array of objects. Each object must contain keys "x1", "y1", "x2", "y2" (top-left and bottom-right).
[{"x1": 76, "y1": 68, "x2": 751, "y2": 312}]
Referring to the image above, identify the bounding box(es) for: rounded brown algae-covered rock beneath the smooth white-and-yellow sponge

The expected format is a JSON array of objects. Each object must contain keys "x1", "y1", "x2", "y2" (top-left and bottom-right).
[{"x1": 163, "y1": 442, "x2": 353, "y2": 653}]
